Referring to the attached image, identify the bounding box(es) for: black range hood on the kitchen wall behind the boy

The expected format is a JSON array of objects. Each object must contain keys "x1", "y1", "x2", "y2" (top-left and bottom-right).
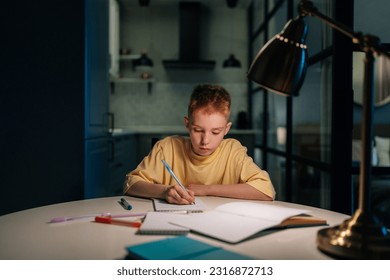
[{"x1": 163, "y1": 2, "x2": 215, "y2": 69}]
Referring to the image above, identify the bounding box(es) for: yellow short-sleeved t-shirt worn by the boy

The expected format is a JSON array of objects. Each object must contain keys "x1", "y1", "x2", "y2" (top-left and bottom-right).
[{"x1": 124, "y1": 136, "x2": 275, "y2": 198}]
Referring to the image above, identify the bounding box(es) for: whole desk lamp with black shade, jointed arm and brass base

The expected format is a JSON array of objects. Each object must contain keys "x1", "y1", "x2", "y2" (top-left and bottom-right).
[{"x1": 248, "y1": 0, "x2": 390, "y2": 259}]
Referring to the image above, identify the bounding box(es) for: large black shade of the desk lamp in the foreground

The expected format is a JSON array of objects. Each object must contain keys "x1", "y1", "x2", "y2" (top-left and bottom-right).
[{"x1": 247, "y1": 17, "x2": 307, "y2": 96}]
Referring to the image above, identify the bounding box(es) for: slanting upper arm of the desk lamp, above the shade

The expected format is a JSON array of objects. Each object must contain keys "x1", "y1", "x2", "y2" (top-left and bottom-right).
[{"x1": 298, "y1": 0, "x2": 390, "y2": 58}]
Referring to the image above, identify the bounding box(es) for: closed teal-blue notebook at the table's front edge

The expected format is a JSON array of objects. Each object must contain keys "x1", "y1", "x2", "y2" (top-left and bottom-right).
[{"x1": 127, "y1": 236, "x2": 251, "y2": 260}]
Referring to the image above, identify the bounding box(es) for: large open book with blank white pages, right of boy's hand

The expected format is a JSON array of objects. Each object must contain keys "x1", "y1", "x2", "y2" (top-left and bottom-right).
[{"x1": 169, "y1": 202, "x2": 326, "y2": 243}]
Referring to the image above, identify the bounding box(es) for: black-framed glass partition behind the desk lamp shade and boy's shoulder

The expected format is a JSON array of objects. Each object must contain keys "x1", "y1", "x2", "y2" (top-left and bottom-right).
[{"x1": 248, "y1": 0, "x2": 353, "y2": 214}]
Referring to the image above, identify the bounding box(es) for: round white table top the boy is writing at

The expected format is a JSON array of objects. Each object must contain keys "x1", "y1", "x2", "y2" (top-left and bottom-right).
[{"x1": 0, "y1": 197, "x2": 349, "y2": 260}]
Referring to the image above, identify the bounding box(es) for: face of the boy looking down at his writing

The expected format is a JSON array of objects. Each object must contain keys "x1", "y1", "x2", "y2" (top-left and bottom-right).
[{"x1": 184, "y1": 110, "x2": 232, "y2": 156}]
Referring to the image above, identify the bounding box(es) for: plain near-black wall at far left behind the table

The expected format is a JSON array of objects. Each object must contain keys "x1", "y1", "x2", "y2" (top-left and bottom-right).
[{"x1": 0, "y1": 0, "x2": 84, "y2": 215}]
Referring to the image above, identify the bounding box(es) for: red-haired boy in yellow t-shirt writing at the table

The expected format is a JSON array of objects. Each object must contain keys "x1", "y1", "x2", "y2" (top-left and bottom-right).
[{"x1": 124, "y1": 85, "x2": 275, "y2": 204}]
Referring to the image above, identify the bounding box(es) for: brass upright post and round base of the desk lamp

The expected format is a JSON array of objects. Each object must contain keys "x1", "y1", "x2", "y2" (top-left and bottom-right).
[{"x1": 310, "y1": 14, "x2": 390, "y2": 259}]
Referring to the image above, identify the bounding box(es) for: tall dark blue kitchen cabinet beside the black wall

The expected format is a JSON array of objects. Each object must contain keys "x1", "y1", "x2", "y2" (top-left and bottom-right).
[{"x1": 84, "y1": 0, "x2": 114, "y2": 198}]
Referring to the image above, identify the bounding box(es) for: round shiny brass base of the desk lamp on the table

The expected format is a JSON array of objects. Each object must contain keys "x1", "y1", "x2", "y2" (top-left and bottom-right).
[{"x1": 317, "y1": 209, "x2": 390, "y2": 259}]
